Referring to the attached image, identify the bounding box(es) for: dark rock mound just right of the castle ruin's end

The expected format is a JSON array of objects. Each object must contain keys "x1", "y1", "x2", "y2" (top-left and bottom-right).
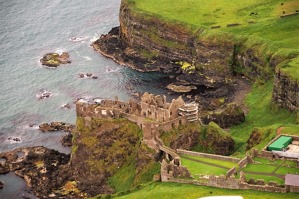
[{"x1": 201, "y1": 103, "x2": 245, "y2": 128}]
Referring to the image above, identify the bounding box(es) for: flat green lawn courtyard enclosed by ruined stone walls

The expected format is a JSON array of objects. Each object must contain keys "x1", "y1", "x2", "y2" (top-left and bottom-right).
[{"x1": 180, "y1": 152, "x2": 299, "y2": 185}]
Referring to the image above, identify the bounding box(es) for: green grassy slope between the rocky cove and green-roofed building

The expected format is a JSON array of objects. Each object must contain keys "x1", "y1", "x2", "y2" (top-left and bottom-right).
[{"x1": 231, "y1": 82, "x2": 299, "y2": 157}]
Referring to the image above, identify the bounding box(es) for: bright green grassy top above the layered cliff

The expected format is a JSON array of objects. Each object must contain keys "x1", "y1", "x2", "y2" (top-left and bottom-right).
[{"x1": 125, "y1": 0, "x2": 299, "y2": 80}]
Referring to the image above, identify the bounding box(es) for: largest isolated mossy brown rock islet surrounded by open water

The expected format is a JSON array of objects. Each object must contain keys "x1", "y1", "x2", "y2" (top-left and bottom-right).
[{"x1": 40, "y1": 52, "x2": 71, "y2": 68}]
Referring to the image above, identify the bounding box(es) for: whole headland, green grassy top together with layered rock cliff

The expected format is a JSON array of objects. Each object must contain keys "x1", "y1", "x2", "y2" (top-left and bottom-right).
[{"x1": 93, "y1": 0, "x2": 299, "y2": 111}]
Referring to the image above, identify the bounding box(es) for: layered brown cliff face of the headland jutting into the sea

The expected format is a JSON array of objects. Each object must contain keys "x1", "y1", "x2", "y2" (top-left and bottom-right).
[{"x1": 93, "y1": 1, "x2": 238, "y2": 91}]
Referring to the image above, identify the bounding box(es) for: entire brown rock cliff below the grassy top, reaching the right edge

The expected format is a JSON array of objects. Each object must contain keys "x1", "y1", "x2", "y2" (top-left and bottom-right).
[{"x1": 93, "y1": 0, "x2": 298, "y2": 110}]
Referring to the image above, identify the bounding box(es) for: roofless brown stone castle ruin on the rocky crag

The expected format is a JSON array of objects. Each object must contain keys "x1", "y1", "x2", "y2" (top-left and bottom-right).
[{"x1": 76, "y1": 93, "x2": 198, "y2": 145}]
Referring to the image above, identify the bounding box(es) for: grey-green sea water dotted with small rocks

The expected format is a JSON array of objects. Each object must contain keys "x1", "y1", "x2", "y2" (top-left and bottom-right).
[{"x1": 0, "y1": 0, "x2": 173, "y2": 198}]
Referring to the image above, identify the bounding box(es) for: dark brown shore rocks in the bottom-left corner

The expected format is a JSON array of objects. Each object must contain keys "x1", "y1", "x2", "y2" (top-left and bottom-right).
[{"x1": 0, "y1": 147, "x2": 70, "y2": 198}]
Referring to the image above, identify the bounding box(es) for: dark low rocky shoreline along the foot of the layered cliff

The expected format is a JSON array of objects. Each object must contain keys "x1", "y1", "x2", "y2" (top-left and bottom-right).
[{"x1": 92, "y1": 27, "x2": 250, "y2": 115}]
